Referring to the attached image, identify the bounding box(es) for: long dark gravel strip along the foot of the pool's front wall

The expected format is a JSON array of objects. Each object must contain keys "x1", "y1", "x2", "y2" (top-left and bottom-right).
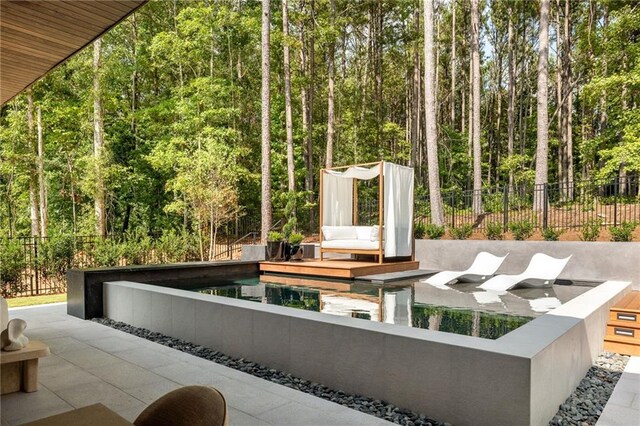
[{"x1": 93, "y1": 318, "x2": 451, "y2": 426}]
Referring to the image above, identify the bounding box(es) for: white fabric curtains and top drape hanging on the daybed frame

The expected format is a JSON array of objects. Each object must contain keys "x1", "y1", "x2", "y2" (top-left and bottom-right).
[{"x1": 321, "y1": 161, "x2": 413, "y2": 257}]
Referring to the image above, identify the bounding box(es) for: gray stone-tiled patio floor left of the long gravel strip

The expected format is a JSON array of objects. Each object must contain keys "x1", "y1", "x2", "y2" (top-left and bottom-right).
[{"x1": 0, "y1": 303, "x2": 390, "y2": 426}]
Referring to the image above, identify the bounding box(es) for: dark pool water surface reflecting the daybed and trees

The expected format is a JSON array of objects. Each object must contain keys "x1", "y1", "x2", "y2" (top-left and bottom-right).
[{"x1": 193, "y1": 277, "x2": 590, "y2": 339}]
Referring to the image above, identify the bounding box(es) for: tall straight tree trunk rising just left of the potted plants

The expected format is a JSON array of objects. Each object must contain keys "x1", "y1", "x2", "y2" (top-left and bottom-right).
[{"x1": 261, "y1": 0, "x2": 271, "y2": 243}]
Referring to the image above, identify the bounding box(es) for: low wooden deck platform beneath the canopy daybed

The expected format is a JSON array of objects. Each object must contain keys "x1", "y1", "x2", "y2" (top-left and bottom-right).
[{"x1": 260, "y1": 259, "x2": 419, "y2": 279}]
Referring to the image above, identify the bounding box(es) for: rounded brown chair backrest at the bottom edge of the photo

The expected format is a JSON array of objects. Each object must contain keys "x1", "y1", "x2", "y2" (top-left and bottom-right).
[{"x1": 133, "y1": 386, "x2": 228, "y2": 426}]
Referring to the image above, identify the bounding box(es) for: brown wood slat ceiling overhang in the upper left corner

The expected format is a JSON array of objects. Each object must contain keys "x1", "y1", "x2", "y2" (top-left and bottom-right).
[{"x1": 0, "y1": 0, "x2": 147, "y2": 105}]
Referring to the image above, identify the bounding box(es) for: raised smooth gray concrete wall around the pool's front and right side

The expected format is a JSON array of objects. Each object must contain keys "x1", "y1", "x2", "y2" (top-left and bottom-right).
[{"x1": 102, "y1": 281, "x2": 631, "y2": 425}]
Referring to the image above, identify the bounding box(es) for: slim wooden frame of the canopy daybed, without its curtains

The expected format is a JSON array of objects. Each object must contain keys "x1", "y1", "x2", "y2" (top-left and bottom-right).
[{"x1": 319, "y1": 161, "x2": 384, "y2": 264}]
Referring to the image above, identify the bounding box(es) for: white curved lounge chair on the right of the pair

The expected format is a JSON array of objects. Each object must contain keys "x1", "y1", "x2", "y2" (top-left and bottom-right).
[{"x1": 480, "y1": 253, "x2": 571, "y2": 291}]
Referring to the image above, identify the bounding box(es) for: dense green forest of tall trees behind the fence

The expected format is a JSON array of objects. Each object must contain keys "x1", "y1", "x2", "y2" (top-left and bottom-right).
[{"x1": 0, "y1": 0, "x2": 640, "y2": 246}]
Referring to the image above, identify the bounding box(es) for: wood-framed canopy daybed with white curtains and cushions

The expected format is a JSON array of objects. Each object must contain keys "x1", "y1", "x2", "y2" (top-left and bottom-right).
[{"x1": 320, "y1": 161, "x2": 413, "y2": 263}]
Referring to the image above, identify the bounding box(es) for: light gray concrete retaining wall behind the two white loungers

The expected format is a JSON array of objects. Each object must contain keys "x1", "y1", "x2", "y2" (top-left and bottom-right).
[{"x1": 416, "y1": 240, "x2": 640, "y2": 290}]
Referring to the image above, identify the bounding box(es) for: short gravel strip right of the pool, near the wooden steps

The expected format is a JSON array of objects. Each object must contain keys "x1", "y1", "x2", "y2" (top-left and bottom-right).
[{"x1": 549, "y1": 352, "x2": 629, "y2": 426}]
